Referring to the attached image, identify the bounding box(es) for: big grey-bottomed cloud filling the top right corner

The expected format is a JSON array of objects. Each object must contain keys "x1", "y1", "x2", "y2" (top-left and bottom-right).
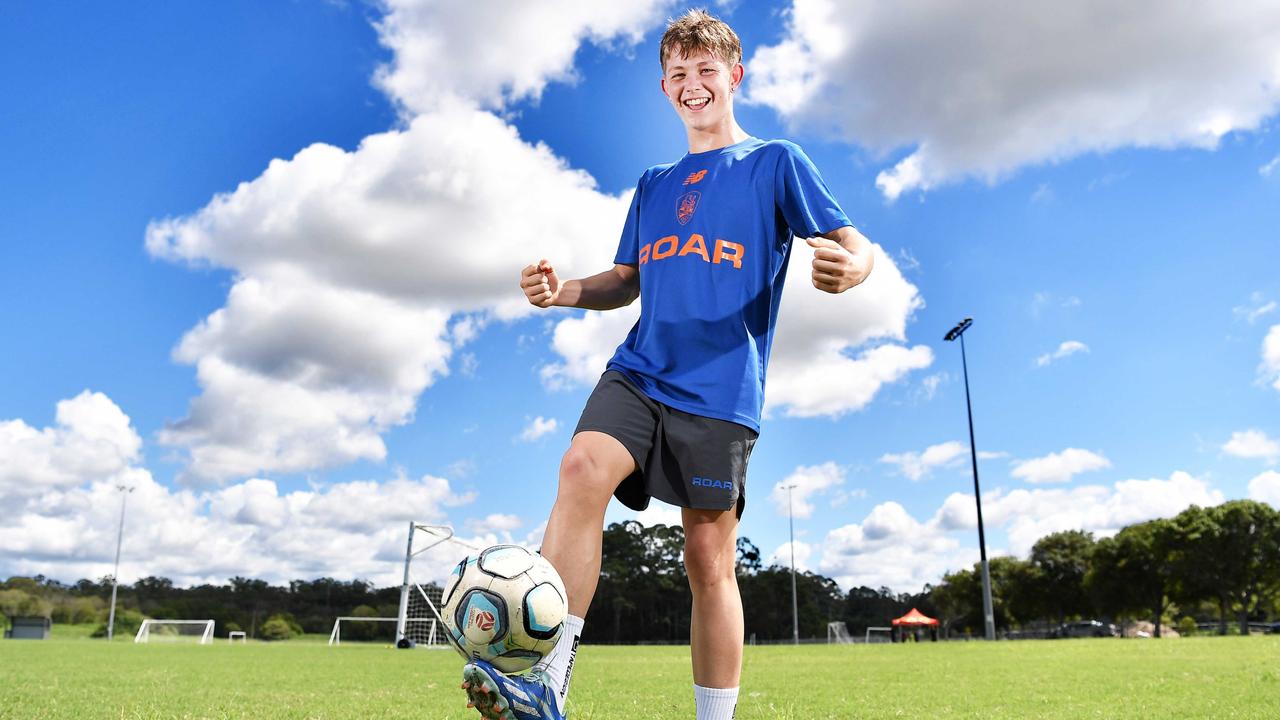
[{"x1": 748, "y1": 0, "x2": 1280, "y2": 200}]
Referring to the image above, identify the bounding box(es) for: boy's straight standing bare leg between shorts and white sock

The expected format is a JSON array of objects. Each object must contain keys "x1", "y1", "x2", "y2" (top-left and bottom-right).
[{"x1": 681, "y1": 507, "x2": 744, "y2": 688}]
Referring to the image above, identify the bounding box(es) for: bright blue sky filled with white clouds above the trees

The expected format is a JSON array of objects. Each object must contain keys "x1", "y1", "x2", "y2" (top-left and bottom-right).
[{"x1": 0, "y1": 0, "x2": 1280, "y2": 592}]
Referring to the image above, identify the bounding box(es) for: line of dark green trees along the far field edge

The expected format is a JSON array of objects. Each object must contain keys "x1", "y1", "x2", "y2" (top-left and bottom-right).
[{"x1": 0, "y1": 501, "x2": 1280, "y2": 643}]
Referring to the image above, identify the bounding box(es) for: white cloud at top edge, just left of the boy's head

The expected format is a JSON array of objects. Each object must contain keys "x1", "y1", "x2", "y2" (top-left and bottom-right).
[{"x1": 376, "y1": 0, "x2": 669, "y2": 114}]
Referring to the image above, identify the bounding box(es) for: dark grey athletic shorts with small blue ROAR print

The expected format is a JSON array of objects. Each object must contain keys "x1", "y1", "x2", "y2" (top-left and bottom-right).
[{"x1": 573, "y1": 370, "x2": 759, "y2": 518}]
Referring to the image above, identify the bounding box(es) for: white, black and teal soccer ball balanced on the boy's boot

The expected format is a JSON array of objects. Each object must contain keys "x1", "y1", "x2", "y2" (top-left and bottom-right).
[{"x1": 440, "y1": 544, "x2": 568, "y2": 674}]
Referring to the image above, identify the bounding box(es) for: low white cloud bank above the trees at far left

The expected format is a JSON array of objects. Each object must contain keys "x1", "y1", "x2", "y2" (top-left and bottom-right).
[{"x1": 0, "y1": 392, "x2": 475, "y2": 584}]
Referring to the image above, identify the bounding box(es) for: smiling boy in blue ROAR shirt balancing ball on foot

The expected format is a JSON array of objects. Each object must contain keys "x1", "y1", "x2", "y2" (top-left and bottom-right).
[{"x1": 462, "y1": 10, "x2": 872, "y2": 720}]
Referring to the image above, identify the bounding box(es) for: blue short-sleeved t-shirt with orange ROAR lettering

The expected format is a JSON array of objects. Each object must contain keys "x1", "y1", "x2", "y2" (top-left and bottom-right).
[{"x1": 608, "y1": 137, "x2": 852, "y2": 432}]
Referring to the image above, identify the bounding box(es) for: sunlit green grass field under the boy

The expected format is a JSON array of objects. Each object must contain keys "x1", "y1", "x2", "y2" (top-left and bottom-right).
[{"x1": 0, "y1": 635, "x2": 1280, "y2": 720}]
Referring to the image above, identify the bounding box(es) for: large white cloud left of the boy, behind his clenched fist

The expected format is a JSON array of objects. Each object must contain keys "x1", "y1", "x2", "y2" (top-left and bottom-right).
[{"x1": 147, "y1": 108, "x2": 627, "y2": 480}]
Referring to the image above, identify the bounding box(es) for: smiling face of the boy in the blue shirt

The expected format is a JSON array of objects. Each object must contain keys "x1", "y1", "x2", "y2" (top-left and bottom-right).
[{"x1": 662, "y1": 47, "x2": 744, "y2": 129}]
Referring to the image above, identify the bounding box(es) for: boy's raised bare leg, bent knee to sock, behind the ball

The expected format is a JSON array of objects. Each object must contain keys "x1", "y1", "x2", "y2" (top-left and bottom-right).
[{"x1": 541, "y1": 430, "x2": 636, "y2": 618}]
